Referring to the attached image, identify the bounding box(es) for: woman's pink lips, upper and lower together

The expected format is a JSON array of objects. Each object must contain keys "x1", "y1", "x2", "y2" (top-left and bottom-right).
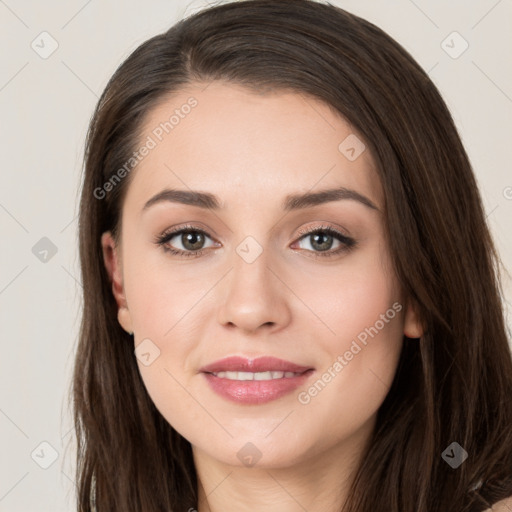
[{"x1": 200, "y1": 356, "x2": 315, "y2": 405}]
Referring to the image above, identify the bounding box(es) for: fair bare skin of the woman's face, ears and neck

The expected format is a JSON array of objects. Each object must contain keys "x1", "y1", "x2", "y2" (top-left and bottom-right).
[{"x1": 102, "y1": 82, "x2": 423, "y2": 512}]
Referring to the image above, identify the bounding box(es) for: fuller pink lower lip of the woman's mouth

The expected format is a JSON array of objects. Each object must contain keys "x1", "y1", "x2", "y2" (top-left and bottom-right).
[{"x1": 203, "y1": 370, "x2": 314, "y2": 404}]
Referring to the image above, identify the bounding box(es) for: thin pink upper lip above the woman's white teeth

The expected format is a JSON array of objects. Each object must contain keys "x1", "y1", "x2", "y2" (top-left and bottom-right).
[{"x1": 199, "y1": 356, "x2": 312, "y2": 373}]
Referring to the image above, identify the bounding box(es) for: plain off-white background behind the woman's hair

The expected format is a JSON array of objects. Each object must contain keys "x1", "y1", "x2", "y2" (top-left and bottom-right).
[{"x1": 0, "y1": 0, "x2": 512, "y2": 512}]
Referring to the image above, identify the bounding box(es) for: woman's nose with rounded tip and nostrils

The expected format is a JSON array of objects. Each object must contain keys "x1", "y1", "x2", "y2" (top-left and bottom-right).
[{"x1": 218, "y1": 242, "x2": 291, "y2": 334}]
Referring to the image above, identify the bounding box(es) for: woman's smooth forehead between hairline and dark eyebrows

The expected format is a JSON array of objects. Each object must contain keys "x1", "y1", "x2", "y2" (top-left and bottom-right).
[{"x1": 124, "y1": 82, "x2": 382, "y2": 207}]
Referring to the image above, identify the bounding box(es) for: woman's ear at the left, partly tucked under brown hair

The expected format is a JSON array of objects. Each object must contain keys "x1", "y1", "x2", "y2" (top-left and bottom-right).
[{"x1": 101, "y1": 231, "x2": 133, "y2": 334}]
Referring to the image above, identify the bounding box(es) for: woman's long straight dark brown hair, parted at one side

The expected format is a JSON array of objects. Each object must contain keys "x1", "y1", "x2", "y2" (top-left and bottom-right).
[{"x1": 72, "y1": 0, "x2": 512, "y2": 512}]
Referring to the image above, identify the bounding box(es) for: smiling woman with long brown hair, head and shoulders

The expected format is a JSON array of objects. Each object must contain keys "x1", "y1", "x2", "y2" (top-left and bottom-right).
[{"x1": 73, "y1": 0, "x2": 512, "y2": 512}]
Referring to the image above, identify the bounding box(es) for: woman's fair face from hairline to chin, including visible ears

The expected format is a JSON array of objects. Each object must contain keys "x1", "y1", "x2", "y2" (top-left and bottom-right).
[{"x1": 102, "y1": 82, "x2": 420, "y2": 467}]
